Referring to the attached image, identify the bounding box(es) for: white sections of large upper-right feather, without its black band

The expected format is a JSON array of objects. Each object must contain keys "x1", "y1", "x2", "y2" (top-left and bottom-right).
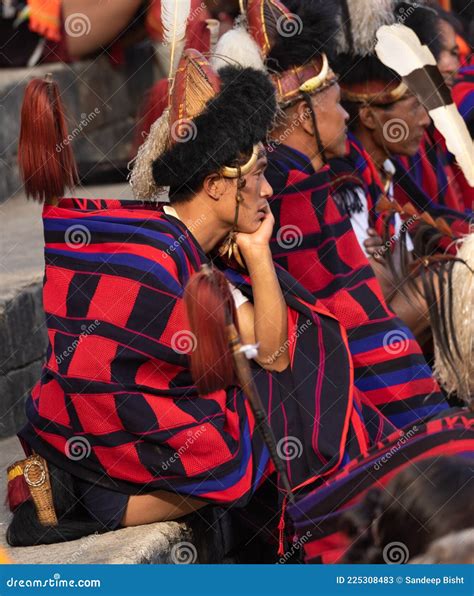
[{"x1": 375, "y1": 24, "x2": 474, "y2": 186}]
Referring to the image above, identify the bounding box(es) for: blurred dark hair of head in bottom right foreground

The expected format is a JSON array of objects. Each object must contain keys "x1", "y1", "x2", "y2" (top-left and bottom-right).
[{"x1": 340, "y1": 457, "x2": 474, "y2": 563}]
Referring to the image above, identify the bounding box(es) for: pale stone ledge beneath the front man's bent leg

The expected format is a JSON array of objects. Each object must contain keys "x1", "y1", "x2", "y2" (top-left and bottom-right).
[{"x1": 0, "y1": 437, "x2": 234, "y2": 565}]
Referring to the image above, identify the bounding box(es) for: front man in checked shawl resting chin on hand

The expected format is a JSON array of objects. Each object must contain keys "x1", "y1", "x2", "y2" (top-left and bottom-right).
[{"x1": 7, "y1": 50, "x2": 394, "y2": 545}]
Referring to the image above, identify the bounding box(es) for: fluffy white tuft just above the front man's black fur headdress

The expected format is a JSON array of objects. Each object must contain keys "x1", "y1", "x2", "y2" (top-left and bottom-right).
[{"x1": 211, "y1": 24, "x2": 266, "y2": 72}]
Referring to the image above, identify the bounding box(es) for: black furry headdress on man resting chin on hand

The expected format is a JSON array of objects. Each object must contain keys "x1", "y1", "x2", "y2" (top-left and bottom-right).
[{"x1": 153, "y1": 66, "x2": 276, "y2": 202}]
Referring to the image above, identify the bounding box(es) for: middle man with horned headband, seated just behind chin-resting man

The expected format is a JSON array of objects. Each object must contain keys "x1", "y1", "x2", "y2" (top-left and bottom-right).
[{"x1": 218, "y1": 0, "x2": 446, "y2": 426}]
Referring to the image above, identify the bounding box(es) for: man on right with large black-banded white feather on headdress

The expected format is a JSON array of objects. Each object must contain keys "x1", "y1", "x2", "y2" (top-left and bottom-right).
[{"x1": 331, "y1": 1, "x2": 474, "y2": 406}]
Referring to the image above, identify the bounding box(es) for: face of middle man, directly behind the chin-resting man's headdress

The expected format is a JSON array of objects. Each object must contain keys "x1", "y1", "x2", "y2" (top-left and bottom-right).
[{"x1": 312, "y1": 83, "x2": 349, "y2": 159}]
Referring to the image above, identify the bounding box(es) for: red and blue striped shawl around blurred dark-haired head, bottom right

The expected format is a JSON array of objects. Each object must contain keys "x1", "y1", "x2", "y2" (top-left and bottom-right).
[{"x1": 287, "y1": 410, "x2": 474, "y2": 563}]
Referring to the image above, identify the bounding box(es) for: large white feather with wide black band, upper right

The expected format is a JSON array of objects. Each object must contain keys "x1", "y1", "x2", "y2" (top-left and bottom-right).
[{"x1": 375, "y1": 24, "x2": 474, "y2": 186}]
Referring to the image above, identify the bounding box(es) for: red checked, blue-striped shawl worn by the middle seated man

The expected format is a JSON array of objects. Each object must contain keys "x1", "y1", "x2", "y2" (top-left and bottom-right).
[{"x1": 267, "y1": 145, "x2": 446, "y2": 427}]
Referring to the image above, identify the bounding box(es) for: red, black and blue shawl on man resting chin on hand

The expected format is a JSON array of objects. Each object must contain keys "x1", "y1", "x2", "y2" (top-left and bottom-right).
[{"x1": 19, "y1": 199, "x2": 393, "y2": 504}]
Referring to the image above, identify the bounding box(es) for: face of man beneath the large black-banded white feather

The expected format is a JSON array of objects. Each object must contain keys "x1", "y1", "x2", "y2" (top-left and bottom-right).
[{"x1": 370, "y1": 95, "x2": 430, "y2": 157}]
